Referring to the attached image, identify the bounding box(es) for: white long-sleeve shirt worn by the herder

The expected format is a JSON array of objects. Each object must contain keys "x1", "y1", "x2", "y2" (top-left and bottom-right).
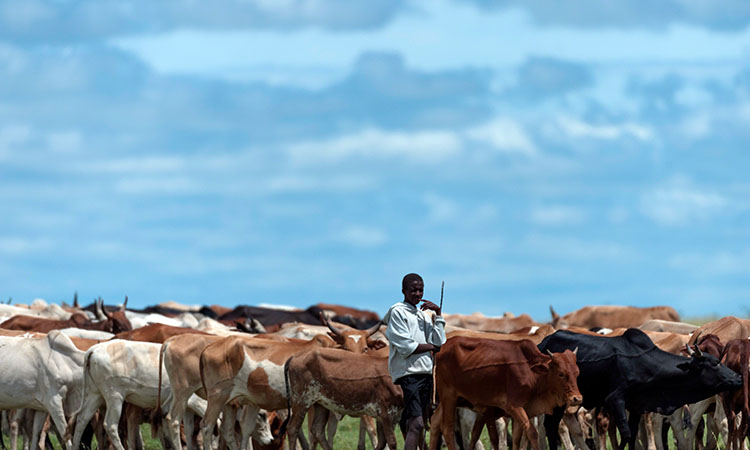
[{"x1": 383, "y1": 302, "x2": 445, "y2": 381}]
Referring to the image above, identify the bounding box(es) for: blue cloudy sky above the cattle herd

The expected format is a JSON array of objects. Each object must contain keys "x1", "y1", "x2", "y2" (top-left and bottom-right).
[{"x1": 0, "y1": 0, "x2": 750, "y2": 320}]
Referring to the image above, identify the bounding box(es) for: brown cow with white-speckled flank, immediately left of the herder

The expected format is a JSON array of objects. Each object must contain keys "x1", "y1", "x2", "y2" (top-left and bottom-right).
[{"x1": 285, "y1": 348, "x2": 403, "y2": 450}]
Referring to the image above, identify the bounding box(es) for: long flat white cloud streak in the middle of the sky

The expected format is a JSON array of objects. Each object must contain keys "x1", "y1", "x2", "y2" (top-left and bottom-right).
[{"x1": 286, "y1": 129, "x2": 462, "y2": 165}]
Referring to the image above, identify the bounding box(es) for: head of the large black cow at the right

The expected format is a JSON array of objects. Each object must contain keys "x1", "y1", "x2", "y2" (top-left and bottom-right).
[{"x1": 677, "y1": 344, "x2": 742, "y2": 392}]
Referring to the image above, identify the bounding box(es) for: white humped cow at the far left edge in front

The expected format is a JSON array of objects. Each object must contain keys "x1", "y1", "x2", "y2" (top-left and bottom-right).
[{"x1": 0, "y1": 331, "x2": 84, "y2": 448}]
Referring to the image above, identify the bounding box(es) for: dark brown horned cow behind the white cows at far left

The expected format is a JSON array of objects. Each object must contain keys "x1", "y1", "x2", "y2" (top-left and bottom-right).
[{"x1": 0, "y1": 301, "x2": 133, "y2": 334}]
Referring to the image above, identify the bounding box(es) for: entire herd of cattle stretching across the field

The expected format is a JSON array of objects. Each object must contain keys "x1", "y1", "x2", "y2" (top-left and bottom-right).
[{"x1": 0, "y1": 298, "x2": 750, "y2": 450}]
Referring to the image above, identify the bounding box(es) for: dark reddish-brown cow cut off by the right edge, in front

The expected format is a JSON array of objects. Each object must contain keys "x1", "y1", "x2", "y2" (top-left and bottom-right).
[{"x1": 719, "y1": 339, "x2": 750, "y2": 450}]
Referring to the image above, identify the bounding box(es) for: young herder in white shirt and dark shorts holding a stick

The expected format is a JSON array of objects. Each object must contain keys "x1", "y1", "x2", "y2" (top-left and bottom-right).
[{"x1": 383, "y1": 273, "x2": 445, "y2": 450}]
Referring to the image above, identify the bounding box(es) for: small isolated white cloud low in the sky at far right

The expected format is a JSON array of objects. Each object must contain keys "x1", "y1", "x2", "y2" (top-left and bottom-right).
[{"x1": 641, "y1": 182, "x2": 728, "y2": 225}]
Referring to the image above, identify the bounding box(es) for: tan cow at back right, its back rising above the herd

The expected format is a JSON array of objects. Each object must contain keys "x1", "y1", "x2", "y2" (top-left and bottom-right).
[{"x1": 549, "y1": 306, "x2": 680, "y2": 330}]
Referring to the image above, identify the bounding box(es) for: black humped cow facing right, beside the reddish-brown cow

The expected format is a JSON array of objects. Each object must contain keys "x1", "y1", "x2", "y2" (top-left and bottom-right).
[{"x1": 539, "y1": 328, "x2": 742, "y2": 450}]
